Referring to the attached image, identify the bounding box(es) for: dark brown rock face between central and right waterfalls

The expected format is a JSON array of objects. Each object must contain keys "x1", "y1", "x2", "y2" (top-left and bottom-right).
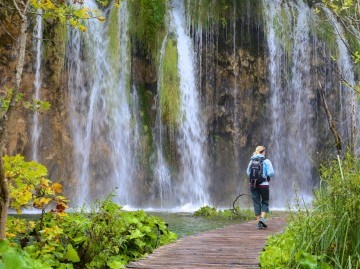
[{"x1": 197, "y1": 19, "x2": 270, "y2": 204}]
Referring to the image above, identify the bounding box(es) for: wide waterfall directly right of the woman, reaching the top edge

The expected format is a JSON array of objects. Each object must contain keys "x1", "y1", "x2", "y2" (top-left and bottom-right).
[{"x1": 263, "y1": 0, "x2": 316, "y2": 207}]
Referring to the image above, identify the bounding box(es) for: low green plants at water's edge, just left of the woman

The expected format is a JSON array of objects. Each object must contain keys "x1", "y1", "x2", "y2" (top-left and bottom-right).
[{"x1": 193, "y1": 206, "x2": 254, "y2": 220}]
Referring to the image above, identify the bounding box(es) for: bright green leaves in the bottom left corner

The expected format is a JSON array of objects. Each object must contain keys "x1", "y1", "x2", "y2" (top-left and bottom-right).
[{"x1": 0, "y1": 240, "x2": 51, "y2": 269}]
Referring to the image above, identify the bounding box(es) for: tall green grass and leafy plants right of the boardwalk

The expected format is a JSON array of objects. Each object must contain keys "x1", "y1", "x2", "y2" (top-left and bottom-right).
[{"x1": 260, "y1": 154, "x2": 360, "y2": 269}]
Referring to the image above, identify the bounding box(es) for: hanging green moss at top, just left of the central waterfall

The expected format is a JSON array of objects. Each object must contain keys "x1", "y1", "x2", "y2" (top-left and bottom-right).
[{"x1": 129, "y1": 0, "x2": 167, "y2": 58}]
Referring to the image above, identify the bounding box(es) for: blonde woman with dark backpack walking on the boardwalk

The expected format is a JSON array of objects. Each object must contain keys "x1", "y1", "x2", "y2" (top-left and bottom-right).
[{"x1": 246, "y1": 146, "x2": 275, "y2": 229}]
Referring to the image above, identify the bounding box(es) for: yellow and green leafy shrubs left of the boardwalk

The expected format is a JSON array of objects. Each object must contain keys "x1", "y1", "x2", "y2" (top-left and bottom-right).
[{"x1": 0, "y1": 155, "x2": 177, "y2": 269}]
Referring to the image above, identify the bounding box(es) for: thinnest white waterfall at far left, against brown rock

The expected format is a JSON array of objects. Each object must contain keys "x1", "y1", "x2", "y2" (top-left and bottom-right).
[{"x1": 31, "y1": 9, "x2": 43, "y2": 161}]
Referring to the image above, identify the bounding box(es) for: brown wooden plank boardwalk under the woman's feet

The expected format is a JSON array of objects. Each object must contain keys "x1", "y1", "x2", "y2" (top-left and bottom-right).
[{"x1": 127, "y1": 217, "x2": 285, "y2": 269}]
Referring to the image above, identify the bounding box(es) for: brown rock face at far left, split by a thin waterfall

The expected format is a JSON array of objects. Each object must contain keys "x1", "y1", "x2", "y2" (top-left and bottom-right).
[{"x1": 0, "y1": 13, "x2": 75, "y2": 192}]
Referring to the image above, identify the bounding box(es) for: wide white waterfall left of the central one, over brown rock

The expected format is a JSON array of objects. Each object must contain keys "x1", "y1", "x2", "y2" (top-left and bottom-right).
[{"x1": 68, "y1": 0, "x2": 134, "y2": 205}]
